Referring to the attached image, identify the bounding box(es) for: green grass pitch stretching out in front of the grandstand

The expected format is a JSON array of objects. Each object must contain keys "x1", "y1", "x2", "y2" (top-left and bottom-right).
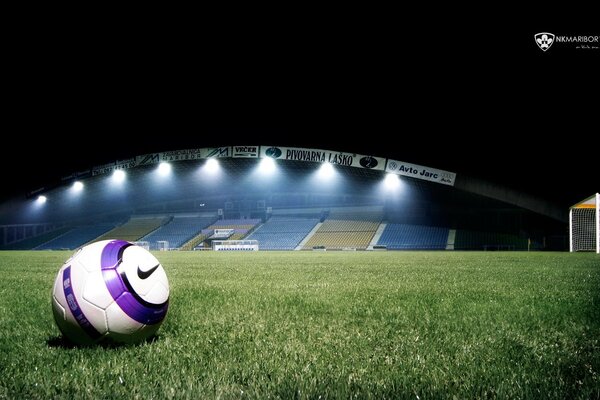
[{"x1": 0, "y1": 252, "x2": 600, "y2": 399}]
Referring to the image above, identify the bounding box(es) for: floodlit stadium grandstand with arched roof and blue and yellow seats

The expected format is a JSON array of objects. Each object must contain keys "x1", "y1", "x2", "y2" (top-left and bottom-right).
[{"x1": 0, "y1": 146, "x2": 568, "y2": 250}]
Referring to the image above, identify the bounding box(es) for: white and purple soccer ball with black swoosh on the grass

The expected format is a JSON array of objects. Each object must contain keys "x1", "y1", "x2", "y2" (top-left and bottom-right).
[{"x1": 52, "y1": 240, "x2": 169, "y2": 345}]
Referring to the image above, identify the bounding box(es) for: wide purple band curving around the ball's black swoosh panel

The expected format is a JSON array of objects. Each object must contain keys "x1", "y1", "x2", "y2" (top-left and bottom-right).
[{"x1": 101, "y1": 240, "x2": 169, "y2": 325}]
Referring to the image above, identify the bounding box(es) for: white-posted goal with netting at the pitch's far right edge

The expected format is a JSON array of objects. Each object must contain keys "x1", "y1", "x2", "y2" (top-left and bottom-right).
[{"x1": 569, "y1": 193, "x2": 600, "y2": 253}]
